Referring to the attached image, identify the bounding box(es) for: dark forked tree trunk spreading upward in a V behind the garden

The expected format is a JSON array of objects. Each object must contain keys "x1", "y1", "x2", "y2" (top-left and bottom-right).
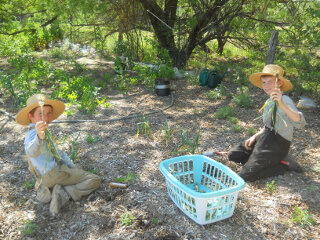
[{"x1": 138, "y1": 0, "x2": 246, "y2": 69}]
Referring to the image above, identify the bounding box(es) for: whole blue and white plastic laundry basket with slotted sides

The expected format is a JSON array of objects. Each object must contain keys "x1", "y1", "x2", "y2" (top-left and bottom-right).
[{"x1": 160, "y1": 155, "x2": 245, "y2": 225}]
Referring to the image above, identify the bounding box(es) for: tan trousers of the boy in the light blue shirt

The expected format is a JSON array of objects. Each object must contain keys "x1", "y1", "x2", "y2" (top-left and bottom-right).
[{"x1": 37, "y1": 165, "x2": 101, "y2": 201}]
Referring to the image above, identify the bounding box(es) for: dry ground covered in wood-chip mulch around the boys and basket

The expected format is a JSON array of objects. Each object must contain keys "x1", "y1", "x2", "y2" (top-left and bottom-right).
[{"x1": 0, "y1": 54, "x2": 320, "y2": 240}]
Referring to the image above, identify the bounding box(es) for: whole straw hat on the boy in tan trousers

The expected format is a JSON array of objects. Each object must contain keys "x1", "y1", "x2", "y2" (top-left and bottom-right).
[{"x1": 16, "y1": 94, "x2": 65, "y2": 125}]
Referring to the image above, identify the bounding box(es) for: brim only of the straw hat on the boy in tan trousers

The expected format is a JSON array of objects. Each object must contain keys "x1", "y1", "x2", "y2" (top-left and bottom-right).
[{"x1": 16, "y1": 100, "x2": 65, "y2": 125}]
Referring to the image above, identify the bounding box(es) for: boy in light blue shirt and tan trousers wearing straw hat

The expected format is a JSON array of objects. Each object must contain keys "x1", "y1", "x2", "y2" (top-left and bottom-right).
[{"x1": 16, "y1": 94, "x2": 101, "y2": 214}]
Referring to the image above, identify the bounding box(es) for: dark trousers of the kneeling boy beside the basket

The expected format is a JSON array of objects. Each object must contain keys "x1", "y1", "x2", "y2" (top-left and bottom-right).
[{"x1": 228, "y1": 128, "x2": 291, "y2": 181}]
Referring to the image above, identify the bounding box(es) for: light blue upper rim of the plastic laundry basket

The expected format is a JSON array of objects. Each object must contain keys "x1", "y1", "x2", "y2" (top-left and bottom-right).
[{"x1": 160, "y1": 155, "x2": 245, "y2": 199}]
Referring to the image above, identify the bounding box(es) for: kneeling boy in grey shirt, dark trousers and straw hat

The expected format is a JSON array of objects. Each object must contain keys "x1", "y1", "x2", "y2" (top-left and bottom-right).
[{"x1": 228, "y1": 64, "x2": 306, "y2": 181}]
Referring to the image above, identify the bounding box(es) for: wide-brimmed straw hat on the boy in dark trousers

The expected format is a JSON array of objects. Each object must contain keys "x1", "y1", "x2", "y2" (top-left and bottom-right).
[{"x1": 249, "y1": 64, "x2": 292, "y2": 92}]
